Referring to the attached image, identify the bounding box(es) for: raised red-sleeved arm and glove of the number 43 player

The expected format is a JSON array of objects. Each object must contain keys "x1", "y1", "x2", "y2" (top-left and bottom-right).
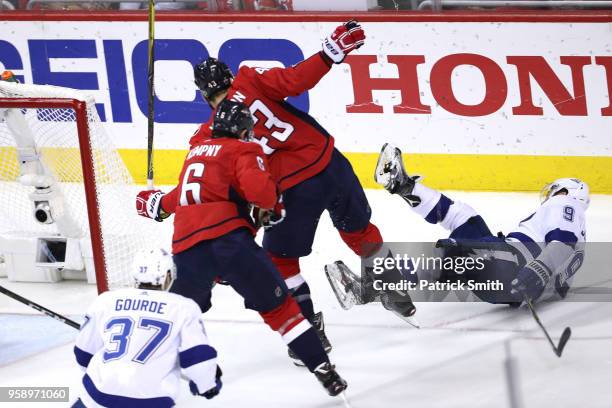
[{"x1": 255, "y1": 20, "x2": 365, "y2": 101}]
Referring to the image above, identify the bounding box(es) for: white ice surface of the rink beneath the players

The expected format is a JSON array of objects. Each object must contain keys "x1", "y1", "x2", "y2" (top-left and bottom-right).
[{"x1": 0, "y1": 191, "x2": 612, "y2": 408}]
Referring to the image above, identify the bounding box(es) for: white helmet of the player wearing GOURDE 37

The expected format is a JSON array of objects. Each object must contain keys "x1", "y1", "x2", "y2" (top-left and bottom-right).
[{"x1": 132, "y1": 248, "x2": 176, "y2": 290}]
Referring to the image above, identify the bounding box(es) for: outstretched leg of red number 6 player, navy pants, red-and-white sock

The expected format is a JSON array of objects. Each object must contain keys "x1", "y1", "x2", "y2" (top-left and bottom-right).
[{"x1": 213, "y1": 230, "x2": 346, "y2": 395}]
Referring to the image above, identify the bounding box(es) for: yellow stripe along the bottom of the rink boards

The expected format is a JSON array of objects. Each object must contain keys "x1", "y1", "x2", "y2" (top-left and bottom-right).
[{"x1": 0, "y1": 147, "x2": 612, "y2": 194}]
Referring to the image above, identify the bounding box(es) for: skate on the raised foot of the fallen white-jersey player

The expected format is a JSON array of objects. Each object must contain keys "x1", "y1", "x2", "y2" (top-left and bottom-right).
[{"x1": 374, "y1": 143, "x2": 422, "y2": 207}]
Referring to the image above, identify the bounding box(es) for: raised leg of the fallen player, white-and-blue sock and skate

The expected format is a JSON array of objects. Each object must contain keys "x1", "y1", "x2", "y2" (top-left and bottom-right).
[{"x1": 375, "y1": 144, "x2": 492, "y2": 239}]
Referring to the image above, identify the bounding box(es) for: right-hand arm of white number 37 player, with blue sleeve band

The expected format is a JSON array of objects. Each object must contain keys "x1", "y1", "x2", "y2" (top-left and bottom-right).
[{"x1": 179, "y1": 301, "x2": 222, "y2": 399}]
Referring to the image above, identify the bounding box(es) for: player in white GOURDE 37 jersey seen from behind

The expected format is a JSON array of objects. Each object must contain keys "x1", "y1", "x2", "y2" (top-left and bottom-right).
[{"x1": 73, "y1": 250, "x2": 222, "y2": 408}]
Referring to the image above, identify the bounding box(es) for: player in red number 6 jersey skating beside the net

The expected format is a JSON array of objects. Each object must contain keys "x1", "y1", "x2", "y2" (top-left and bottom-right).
[{"x1": 138, "y1": 100, "x2": 346, "y2": 395}]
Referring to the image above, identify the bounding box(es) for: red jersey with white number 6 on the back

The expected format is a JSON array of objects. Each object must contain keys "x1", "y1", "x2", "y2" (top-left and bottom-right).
[{"x1": 162, "y1": 137, "x2": 277, "y2": 254}]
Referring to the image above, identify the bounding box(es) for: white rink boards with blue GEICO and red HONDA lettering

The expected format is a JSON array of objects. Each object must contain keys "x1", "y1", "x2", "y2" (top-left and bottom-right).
[{"x1": 0, "y1": 21, "x2": 612, "y2": 156}]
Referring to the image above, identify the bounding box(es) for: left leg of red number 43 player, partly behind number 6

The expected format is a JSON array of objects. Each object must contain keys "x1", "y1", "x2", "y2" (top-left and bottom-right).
[{"x1": 263, "y1": 174, "x2": 332, "y2": 356}]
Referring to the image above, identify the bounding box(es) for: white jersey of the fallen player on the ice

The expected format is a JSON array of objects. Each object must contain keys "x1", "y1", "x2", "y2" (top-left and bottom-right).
[{"x1": 506, "y1": 195, "x2": 587, "y2": 300}]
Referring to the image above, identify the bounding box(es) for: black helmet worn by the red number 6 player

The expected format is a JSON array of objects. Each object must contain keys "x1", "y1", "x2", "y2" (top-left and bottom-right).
[{"x1": 213, "y1": 99, "x2": 255, "y2": 139}]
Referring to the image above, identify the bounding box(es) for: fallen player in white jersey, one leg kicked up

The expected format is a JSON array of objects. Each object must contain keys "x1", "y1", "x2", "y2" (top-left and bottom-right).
[{"x1": 327, "y1": 144, "x2": 589, "y2": 315}]
